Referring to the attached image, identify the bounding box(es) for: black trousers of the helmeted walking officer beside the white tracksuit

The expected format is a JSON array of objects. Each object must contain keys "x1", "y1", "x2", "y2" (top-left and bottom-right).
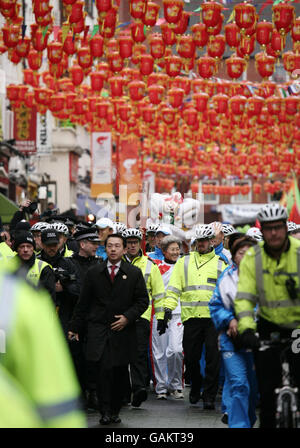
[{"x1": 183, "y1": 318, "x2": 220, "y2": 401}]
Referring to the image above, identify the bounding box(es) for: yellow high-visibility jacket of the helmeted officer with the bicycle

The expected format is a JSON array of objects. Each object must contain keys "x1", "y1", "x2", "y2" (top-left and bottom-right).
[{"x1": 234, "y1": 237, "x2": 300, "y2": 333}]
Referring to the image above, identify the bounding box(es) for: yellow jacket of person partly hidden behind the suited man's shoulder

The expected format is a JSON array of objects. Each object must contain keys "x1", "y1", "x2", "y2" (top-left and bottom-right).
[{"x1": 126, "y1": 255, "x2": 165, "y2": 321}]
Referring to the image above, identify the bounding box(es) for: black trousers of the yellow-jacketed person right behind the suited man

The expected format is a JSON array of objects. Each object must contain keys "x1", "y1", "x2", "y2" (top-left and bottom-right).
[{"x1": 130, "y1": 318, "x2": 150, "y2": 393}]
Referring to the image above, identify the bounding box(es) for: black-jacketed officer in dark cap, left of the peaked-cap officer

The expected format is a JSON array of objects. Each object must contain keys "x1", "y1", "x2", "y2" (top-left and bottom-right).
[{"x1": 38, "y1": 228, "x2": 80, "y2": 336}]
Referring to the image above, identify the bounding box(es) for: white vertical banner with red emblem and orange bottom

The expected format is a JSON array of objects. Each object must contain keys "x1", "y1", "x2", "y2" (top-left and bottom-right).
[{"x1": 91, "y1": 132, "x2": 112, "y2": 197}]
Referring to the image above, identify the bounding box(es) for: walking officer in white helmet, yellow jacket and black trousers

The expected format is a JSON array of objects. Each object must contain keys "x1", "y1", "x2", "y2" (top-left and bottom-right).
[{"x1": 165, "y1": 225, "x2": 226, "y2": 409}]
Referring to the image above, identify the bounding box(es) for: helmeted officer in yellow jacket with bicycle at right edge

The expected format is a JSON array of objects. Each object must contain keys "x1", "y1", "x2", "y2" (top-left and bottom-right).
[{"x1": 235, "y1": 203, "x2": 300, "y2": 428}]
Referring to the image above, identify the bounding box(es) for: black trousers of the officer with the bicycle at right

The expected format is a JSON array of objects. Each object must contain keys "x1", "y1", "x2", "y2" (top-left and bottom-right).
[{"x1": 254, "y1": 318, "x2": 300, "y2": 428}]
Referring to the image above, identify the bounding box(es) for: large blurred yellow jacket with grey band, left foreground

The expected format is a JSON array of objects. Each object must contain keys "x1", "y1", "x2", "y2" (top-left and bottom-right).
[{"x1": 0, "y1": 269, "x2": 86, "y2": 428}]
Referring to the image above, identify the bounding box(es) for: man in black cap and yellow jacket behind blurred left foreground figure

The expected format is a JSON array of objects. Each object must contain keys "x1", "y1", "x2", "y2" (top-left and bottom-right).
[{"x1": 7, "y1": 232, "x2": 56, "y2": 303}]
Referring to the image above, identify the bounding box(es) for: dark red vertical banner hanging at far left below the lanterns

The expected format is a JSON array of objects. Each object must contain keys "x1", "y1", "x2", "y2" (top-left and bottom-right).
[{"x1": 14, "y1": 104, "x2": 37, "y2": 155}]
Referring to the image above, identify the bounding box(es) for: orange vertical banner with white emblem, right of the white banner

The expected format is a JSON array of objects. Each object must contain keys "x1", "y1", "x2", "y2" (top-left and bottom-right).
[{"x1": 119, "y1": 139, "x2": 142, "y2": 205}]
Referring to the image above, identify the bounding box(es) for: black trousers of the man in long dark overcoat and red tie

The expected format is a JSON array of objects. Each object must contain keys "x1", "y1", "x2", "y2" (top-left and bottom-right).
[{"x1": 96, "y1": 347, "x2": 128, "y2": 415}]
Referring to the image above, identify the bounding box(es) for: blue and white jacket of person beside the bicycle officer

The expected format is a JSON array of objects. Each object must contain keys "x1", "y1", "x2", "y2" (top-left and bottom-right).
[{"x1": 208, "y1": 263, "x2": 238, "y2": 351}]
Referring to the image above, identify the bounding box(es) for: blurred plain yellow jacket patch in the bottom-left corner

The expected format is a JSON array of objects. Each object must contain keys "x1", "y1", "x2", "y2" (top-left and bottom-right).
[{"x1": 0, "y1": 364, "x2": 45, "y2": 428}]
